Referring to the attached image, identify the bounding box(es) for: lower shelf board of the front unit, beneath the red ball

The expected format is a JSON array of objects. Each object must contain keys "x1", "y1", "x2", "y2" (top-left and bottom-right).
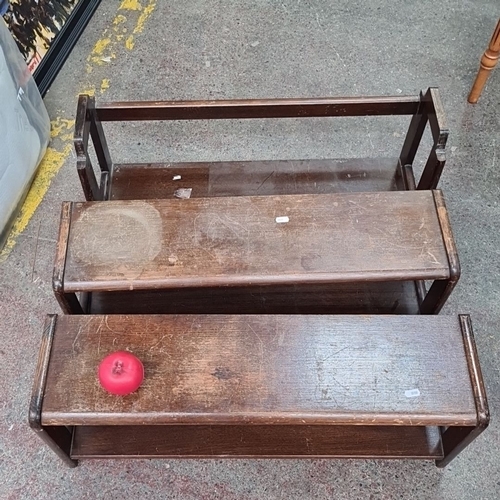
[{"x1": 71, "y1": 425, "x2": 443, "y2": 458}]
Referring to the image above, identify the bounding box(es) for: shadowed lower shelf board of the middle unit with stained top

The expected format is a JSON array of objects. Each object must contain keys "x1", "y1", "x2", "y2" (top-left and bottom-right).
[{"x1": 88, "y1": 281, "x2": 419, "y2": 314}]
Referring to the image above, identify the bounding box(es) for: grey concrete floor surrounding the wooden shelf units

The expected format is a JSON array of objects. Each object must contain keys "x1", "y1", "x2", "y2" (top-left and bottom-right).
[{"x1": 0, "y1": 0, "x2": 500, "y2": 500}]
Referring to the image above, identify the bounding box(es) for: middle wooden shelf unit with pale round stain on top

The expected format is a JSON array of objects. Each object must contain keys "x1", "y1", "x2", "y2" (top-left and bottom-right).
[{"x1": 54, "y1": 190, "x2": 460, "y2": 314}]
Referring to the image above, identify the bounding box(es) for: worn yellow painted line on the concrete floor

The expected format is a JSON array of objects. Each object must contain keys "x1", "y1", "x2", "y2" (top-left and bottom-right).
[{"x1": 0, "y1": 0, "x2": 157, "y2": 262}]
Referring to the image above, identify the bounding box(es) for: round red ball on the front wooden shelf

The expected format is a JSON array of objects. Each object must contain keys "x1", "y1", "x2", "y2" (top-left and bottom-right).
[{"x1": 99, "y1": 351, "x2": 144, "y2": 396}]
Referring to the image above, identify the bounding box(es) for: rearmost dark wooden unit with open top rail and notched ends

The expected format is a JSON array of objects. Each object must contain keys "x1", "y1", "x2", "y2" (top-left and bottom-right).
[{"x1": 74, "y1": 88, "x2": 448, "y2": 201}]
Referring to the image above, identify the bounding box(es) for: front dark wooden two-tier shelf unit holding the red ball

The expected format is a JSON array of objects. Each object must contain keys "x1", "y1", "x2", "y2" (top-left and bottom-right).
[{"x1": 30, "y1": 315, "x2": 489, "y2": 466}]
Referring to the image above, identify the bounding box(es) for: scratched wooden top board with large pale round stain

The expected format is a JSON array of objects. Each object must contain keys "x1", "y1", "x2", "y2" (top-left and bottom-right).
[{"x1": 64, "y1": 191, "x2": 450, "y2": 292}]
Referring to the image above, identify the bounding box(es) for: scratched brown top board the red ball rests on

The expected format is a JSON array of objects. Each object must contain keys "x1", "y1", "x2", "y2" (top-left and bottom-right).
[{"x1": 42, "y1": 315, "x2": 477, "y2": 426}]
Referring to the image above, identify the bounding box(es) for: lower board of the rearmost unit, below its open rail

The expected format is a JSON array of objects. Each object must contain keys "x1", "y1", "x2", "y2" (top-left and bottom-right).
[{"x1": 108, "y1": 158, "x2": 403, "y2": 200}]
